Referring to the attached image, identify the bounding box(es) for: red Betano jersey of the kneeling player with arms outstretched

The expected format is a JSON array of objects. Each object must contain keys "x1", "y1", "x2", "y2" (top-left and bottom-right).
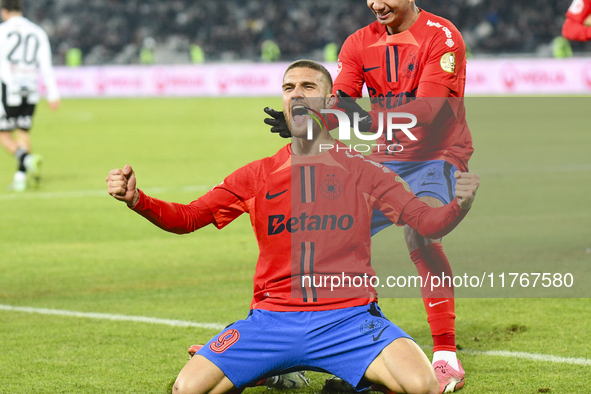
[{"x1": 133, "y1": 143, "x2": 467, "y2": 311}]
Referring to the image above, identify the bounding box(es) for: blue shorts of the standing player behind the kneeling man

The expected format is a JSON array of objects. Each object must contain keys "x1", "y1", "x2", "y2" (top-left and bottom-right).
[{"x1": 371, "y1": 160, "x2": 458, "y2": 235}]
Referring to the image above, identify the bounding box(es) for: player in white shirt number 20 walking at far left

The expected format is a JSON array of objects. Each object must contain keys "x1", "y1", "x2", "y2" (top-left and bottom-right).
[{"x1": 0, "y1": 0, "x2": 60, "y2": 191}]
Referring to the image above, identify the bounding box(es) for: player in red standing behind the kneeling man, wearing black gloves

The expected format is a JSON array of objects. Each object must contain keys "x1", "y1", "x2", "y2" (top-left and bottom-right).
[{"x1": 265, "y1": 0, "x2": 473, "y2": 392}]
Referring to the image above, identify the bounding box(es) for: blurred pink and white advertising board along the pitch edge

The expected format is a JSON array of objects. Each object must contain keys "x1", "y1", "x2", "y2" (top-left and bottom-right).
[{"x1": 40, "y1": 58, "x2": 591, "y2": 98}]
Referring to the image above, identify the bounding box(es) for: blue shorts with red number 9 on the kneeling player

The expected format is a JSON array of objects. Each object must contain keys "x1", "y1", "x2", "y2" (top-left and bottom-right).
[{"x1": 197, "y1": 303, "x2": 412, "y2": 390}]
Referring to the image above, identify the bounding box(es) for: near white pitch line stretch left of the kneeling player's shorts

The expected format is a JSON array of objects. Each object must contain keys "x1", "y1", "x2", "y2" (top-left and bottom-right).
[{"x1": 0, "y1": 304, "x2": 226, "y2": 331}]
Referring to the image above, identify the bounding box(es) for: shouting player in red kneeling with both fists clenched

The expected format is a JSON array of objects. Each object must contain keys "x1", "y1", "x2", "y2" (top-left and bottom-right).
[{"x1": 106, "y1": 61, "x2": 479, "y2": 394}]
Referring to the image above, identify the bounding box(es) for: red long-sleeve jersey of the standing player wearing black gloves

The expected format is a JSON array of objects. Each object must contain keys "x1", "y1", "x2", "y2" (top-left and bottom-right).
[{"x1": 333, "y1": 10, "x2": 473, "y2": 170}]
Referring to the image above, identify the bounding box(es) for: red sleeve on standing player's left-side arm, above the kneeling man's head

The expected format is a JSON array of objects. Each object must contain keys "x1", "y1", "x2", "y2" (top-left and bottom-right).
[{"x1": 332, "y1": 33, "x2": 365, "y2": 97}]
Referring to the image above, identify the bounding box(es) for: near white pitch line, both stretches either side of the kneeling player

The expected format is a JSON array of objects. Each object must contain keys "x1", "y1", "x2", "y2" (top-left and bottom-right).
[{"x1": 0, "y1": 304, "x2": 591, "y2": 366}]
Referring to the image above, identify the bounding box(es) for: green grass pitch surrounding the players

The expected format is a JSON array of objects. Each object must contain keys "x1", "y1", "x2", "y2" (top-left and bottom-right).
[{"x1": 0, "y1": 98, "x2": 591, "y2": 394}]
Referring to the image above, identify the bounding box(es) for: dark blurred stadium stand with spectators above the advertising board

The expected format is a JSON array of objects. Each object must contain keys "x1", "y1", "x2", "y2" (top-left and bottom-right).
[{"x1": 25, "y1": 0, "x2": 591, "y2": 65}]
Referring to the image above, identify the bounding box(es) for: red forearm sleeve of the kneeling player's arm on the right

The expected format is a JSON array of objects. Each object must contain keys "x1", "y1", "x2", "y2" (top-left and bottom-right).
[{"x1": 400, "y1": 198, "x2": 469, "y2": 239}]
